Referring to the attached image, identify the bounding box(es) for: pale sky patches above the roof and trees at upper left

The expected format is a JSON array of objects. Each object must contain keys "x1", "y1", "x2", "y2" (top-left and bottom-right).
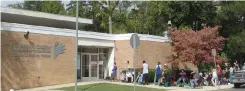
[{"x1": 1, "y1": 0, "x2": 70, "y2": 7}]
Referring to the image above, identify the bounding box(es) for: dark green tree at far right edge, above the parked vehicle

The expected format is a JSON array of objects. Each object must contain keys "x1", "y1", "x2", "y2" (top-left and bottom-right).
[{"x1": 217, "y1": 2, "x2": 245, "y2": 65}]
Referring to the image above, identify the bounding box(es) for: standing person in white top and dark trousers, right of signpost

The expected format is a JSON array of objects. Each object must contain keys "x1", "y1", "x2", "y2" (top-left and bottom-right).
[{"x1": 142, "y1": 60, "x2": 148, "y2": 85}]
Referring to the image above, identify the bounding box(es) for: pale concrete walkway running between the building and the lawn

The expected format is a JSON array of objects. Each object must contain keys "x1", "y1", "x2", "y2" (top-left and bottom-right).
[{"x1": 15, "y1": 81, "x2": 233, "y2": 91}]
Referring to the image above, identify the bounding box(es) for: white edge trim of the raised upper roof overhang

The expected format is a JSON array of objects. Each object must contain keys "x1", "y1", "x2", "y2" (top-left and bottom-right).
[{"x1": 1, "y1": 7, "x2": 93, "y2": 24}]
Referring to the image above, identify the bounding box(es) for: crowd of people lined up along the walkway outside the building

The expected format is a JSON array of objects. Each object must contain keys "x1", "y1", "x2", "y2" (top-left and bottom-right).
[{"x1": 111, "y1": 60, "x2": 242, "y2": 88}]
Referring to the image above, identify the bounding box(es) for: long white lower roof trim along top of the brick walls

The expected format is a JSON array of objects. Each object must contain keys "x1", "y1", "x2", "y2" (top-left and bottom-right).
[{"x1": 1, "y1": 22, "x2": 170, "y2": 42}]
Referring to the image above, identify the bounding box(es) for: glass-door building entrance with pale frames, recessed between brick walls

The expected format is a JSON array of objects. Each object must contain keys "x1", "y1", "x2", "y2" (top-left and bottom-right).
[{"x1": 77, "y1": 48, "x2": 107, "y2": 81}]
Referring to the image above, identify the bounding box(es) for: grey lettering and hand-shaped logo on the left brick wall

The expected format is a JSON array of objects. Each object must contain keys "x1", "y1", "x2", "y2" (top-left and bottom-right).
[{"x1": 10, "y1": 43, "x2": 64, "y2": 58}]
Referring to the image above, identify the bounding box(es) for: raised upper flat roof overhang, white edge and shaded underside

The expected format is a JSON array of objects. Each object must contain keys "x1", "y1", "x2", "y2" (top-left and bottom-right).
[{"x1": 1, "y1": 7, "x2": 93, "y2": 29}]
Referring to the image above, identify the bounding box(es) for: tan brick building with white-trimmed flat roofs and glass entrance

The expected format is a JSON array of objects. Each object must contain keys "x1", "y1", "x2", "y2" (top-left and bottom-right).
[{"x1": 0, "y1": 8, "x2": 193, "y2": 91}]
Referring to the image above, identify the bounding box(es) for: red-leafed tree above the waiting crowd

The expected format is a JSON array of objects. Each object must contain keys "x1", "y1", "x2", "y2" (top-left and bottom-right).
[{"x1": 168, "y1": 26, "x2": 227, "y2": 66}]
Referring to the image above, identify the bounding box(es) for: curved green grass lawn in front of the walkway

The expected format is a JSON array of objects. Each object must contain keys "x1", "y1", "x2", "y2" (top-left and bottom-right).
[{"x1": 55, "y1": 83, "x2": 165, "y2": 91}]
